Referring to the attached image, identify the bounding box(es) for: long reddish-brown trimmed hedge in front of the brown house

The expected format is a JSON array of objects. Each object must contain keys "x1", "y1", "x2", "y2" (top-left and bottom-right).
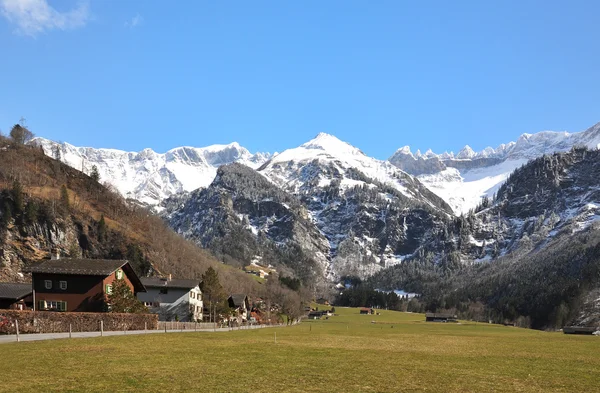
[{"x1": 0, "y1": 310, "x2": 158, "y2": 334}]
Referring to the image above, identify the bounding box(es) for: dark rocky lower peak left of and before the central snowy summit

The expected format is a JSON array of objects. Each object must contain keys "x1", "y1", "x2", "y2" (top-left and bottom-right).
[{"x1": 168, "y1": 164, "x2": 329, "y2": 285}]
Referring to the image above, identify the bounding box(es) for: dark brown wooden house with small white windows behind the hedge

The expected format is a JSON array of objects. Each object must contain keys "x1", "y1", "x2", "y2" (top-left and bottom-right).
[{"x1": 30, "y1": 258, "x2": 146, "y2": 312}]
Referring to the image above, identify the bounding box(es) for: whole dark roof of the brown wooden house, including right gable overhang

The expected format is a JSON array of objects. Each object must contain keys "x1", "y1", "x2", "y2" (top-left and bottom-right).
[{"x1": 29, "y1": 258, "x2": 146, "y2": 292}]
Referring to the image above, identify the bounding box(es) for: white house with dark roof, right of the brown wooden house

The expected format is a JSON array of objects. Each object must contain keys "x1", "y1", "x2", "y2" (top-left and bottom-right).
[{"x1": 137, "y1": 275, "x2": 203, "y2": 322}]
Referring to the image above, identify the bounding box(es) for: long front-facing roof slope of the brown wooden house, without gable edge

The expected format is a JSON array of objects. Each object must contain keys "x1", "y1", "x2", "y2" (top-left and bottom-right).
[{"x1": 29, "y1": 258, "x2": 128, "y2": 276}]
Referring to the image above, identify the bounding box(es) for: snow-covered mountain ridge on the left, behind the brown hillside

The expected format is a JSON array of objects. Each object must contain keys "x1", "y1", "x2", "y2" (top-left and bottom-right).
[{"x1": 30, "y1": 138, "x2": 270, "y2": 206}]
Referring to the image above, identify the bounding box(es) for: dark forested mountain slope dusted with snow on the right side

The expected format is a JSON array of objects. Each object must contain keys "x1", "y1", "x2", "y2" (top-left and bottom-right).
[{"x1": 372, "y1": 148, "x2": 600, "y2": 327}]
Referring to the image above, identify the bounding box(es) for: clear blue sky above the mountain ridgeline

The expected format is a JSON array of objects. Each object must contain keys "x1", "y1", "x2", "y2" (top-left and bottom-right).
[{"x1": 0, "y1": 0, "x2": 600, "y2": 159}]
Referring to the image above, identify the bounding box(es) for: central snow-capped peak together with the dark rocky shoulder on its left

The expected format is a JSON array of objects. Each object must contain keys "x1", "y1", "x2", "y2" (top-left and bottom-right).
[{"x1": 166, "y1": 133, "x2": 452, "y2": 278}]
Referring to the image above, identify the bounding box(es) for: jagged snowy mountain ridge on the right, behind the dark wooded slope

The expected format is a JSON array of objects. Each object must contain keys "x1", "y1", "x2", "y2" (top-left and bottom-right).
[{"x1": 389, "y1": 123, "x2": 600, "y2": 214}]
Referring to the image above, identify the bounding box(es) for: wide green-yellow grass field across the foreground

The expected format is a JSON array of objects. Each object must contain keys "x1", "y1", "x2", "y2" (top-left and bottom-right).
[{"x1": 0, "y1": 308, "x2": 600, "y2": 392}]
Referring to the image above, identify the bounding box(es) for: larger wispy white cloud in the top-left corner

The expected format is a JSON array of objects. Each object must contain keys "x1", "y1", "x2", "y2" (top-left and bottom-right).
[{"x1": 0, "y1": 0, "x2": 90, "y2": 37}]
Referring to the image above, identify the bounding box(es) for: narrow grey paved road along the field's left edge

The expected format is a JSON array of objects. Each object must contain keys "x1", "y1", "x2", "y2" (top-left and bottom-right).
[{"x1": 0, "y1": 325, "x2": 282, "y2": 344}]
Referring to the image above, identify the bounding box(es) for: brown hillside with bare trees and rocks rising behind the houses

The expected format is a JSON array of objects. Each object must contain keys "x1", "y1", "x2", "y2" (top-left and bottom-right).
[{"x1": 0, "y1": 133, "x2": 300, "y2": 309}]
